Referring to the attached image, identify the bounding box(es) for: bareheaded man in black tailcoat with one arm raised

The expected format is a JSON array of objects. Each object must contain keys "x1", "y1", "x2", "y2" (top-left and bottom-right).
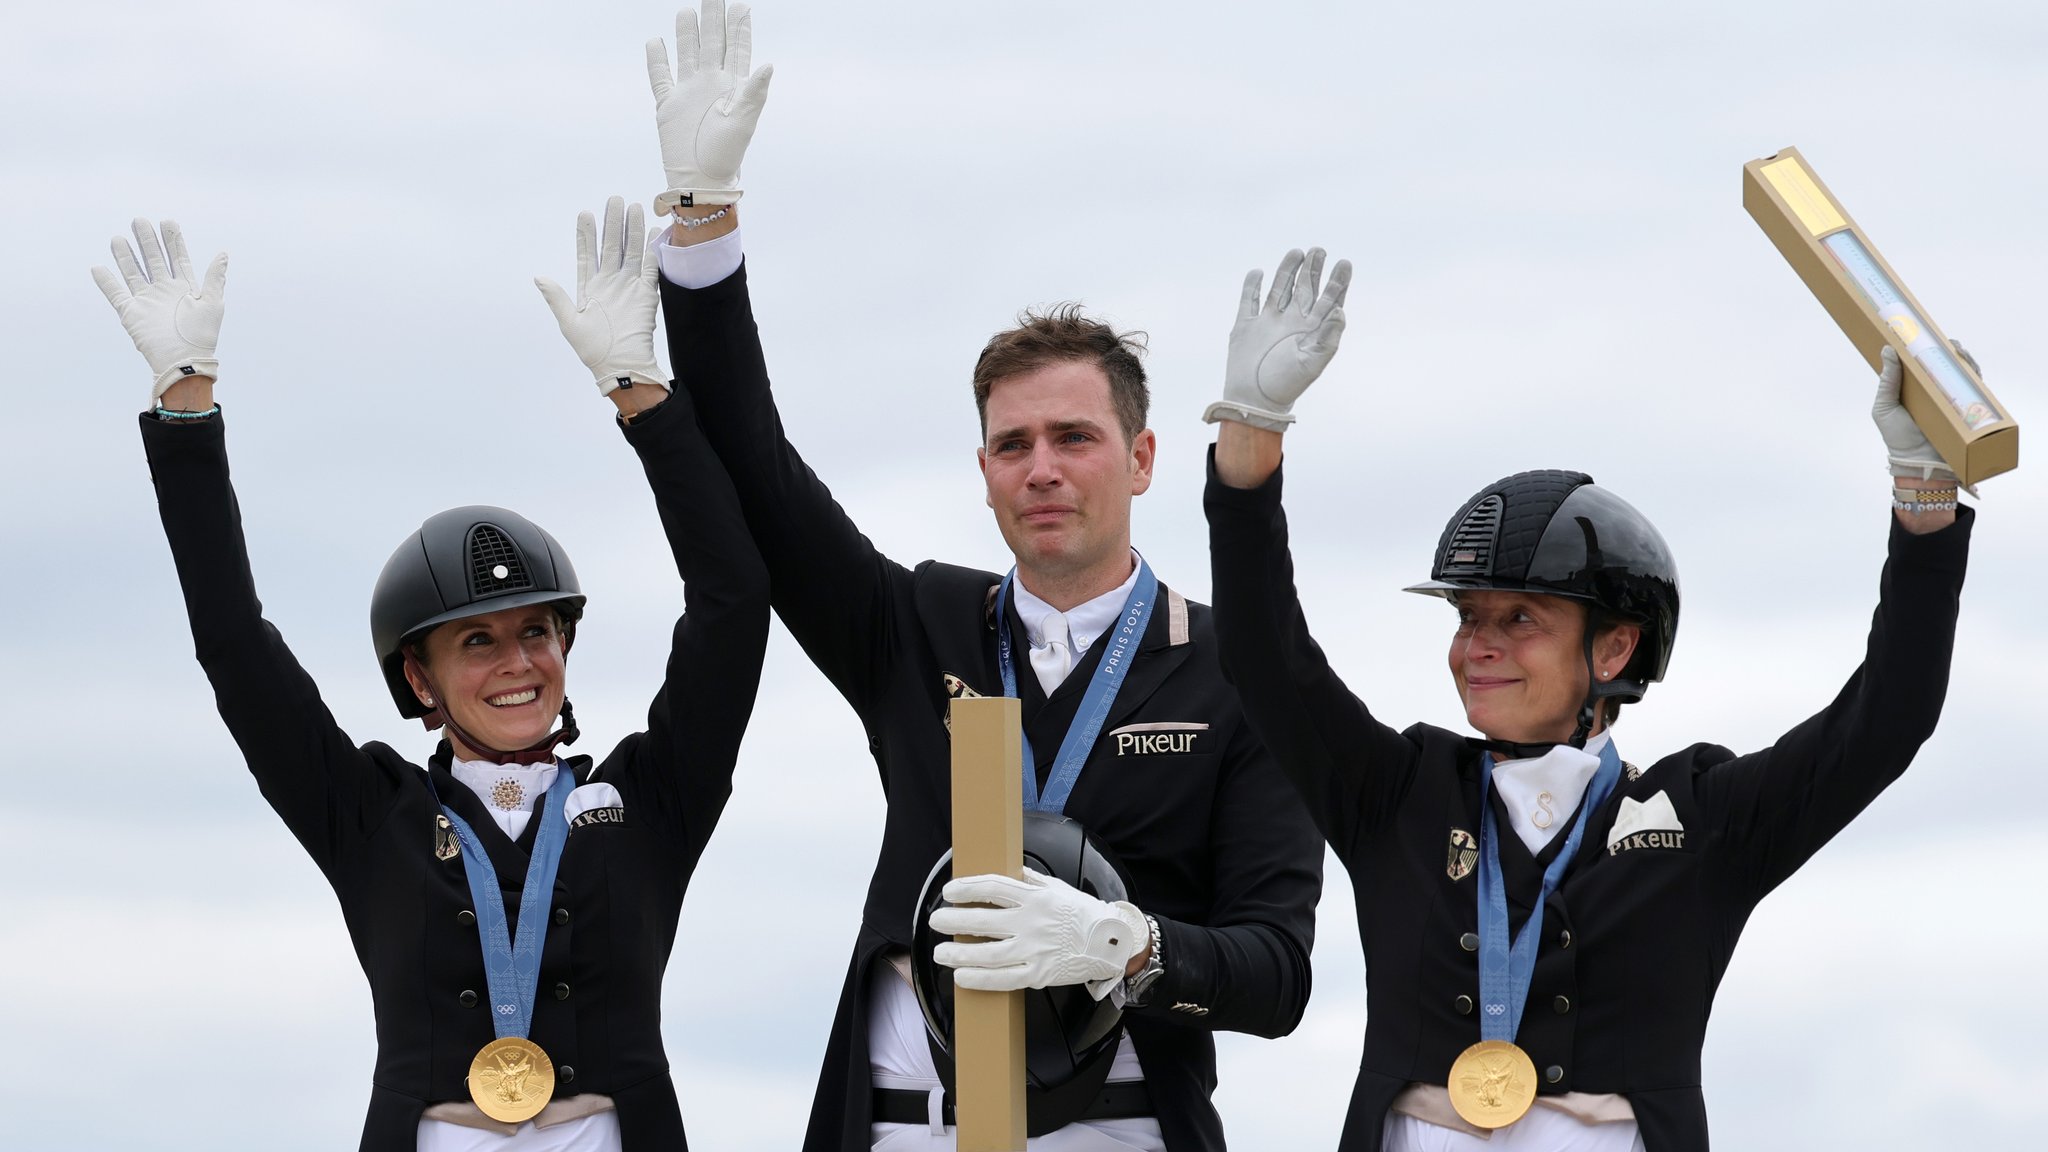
[{"x1": 630, "y1": 0, "x2": 1321, "y2": 1152}]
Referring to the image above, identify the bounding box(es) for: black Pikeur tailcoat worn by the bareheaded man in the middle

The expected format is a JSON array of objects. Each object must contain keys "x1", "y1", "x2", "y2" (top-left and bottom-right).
[{"x1": 662, "y1": 269, "x2": 1323, "y2": 1152}]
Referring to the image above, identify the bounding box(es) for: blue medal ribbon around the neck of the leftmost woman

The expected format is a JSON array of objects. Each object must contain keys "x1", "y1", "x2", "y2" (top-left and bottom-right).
[{"x1": 428, "y1": 765, "x2": 575, "y2": 1039}]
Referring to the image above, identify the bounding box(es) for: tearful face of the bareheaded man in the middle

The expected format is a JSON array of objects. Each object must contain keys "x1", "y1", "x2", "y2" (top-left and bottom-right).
[{"x1": 977, "y1": 361, "x2": 1155, "y2": 580}]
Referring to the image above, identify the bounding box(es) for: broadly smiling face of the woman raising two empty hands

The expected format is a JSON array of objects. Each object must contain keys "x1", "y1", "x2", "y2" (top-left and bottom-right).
[{"x1": 406, "y1": 605, "x2": 567, "y2": 760}]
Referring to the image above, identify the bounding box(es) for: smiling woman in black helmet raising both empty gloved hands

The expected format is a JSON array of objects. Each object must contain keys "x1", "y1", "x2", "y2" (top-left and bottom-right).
[{"x1": 94, "y1": 199, "x2": 768, "y2": 1152}]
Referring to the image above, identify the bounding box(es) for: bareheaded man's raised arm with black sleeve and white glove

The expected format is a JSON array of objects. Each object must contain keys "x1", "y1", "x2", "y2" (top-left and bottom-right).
[{"x1": 647, "y1": 0, "x2": 909, "y2": 707}]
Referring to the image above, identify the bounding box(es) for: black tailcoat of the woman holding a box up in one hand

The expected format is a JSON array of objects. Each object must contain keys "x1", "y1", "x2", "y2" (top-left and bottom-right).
[{"x1": 1206, "y1": 453, "x2": 1972, "y2": 1152}]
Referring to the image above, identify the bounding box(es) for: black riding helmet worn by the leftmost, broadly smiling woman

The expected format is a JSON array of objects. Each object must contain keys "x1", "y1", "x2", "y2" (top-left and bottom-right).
[{"x1": 371, "y1": 504, "x2": 584, "y2": 719}]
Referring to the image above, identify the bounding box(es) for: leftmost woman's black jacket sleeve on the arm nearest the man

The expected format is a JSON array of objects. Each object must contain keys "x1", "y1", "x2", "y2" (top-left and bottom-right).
[{"x1": 621, "y1": 392, "x2": 768, "y2": 859}]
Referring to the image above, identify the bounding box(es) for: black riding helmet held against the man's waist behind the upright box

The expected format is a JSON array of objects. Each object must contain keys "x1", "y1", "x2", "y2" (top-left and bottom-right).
[{"x1": 911, "y1": 812, "x2": 1130, "y2": 1136}]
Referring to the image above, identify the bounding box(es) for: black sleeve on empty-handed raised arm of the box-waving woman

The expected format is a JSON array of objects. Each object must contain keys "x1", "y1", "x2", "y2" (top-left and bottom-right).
[{"x1": 1202, "y1": 451, "x2": 1421, "y2": 859}]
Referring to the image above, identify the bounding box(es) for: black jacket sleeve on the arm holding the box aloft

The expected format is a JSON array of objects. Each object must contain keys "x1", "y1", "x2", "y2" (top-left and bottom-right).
[{"x1": 1696, "y1": 506, "x2": 1976, "y2": 904}]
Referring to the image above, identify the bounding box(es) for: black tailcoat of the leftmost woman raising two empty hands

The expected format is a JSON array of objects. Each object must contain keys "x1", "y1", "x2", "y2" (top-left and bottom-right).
[{"x1": 141, "y1": 396, "x2": 768, "y2": 1152}]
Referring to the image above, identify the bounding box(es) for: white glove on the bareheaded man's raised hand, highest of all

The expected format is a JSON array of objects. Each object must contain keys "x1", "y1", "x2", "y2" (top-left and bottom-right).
[{"x1": 647, "y1": 0, "x2": 774, "y2": 215}]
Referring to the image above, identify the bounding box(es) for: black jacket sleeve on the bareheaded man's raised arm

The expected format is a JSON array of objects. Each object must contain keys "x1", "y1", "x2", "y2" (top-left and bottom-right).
[{"x1": 662, "y1": 266, "x2": 911, "y2": 713}]
